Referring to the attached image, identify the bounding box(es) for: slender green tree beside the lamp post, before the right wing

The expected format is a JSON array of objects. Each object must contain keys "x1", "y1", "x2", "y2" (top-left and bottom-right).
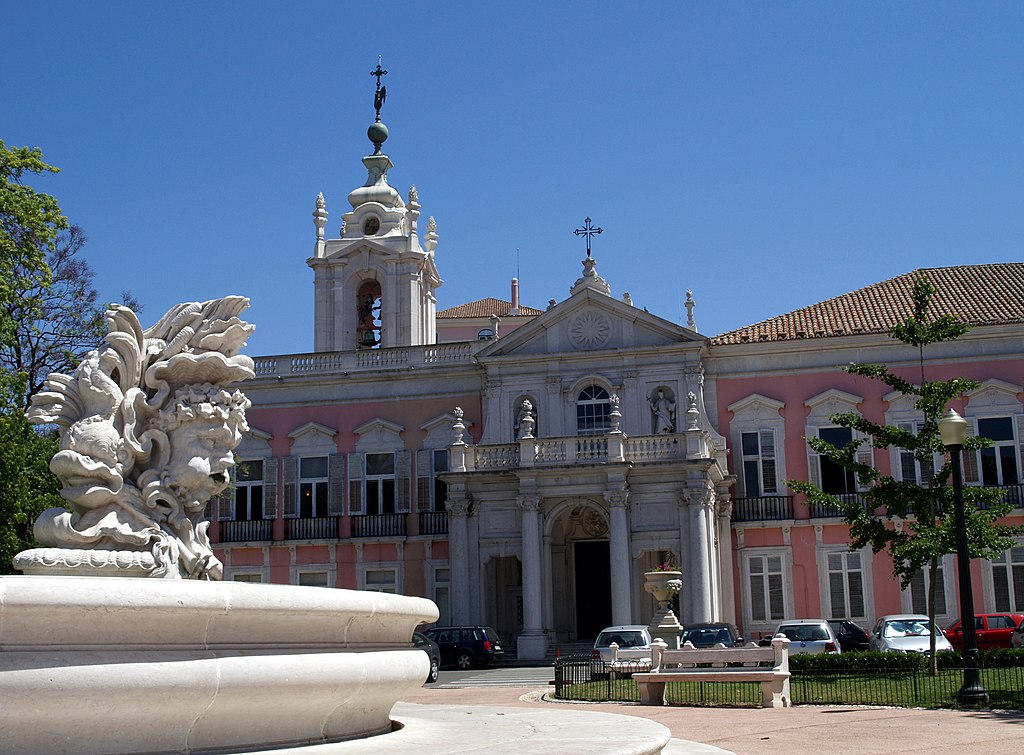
[{"x1": 786, "y1": 276, "x2": 1020, "y2": 673}]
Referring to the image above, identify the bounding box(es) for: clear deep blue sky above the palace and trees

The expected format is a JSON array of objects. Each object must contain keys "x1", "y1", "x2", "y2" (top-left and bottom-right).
[{"x1": 0, "y1": 0, "x2": 1024, "y2": 353}]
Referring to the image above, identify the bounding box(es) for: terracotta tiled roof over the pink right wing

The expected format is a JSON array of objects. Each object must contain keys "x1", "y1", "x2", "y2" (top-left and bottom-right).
[{"x1": 711, "y1": 262, "x2": 1024, "y2": 344}]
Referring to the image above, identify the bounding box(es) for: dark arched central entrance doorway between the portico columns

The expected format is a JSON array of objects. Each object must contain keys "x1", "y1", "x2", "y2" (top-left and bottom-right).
[{"x1": 548, "y1": 500, "x2": 611, "y2": 641}]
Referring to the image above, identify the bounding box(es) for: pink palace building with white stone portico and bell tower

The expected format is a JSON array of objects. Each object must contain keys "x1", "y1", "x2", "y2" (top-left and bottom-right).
[{"x1": 211, "y1": 109, "x2": 1024, "y2": 659}]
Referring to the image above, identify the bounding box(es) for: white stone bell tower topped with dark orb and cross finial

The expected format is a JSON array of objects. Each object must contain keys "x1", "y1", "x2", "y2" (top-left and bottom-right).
[{"x1": 306, "y1": 61, "x2": 442, "y2": 351}]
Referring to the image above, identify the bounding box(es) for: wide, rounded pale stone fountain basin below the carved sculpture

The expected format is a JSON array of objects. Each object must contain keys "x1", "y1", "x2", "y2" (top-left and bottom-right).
[{"x1": 0, "y1": 576, "x2": 437, "y2": 753}]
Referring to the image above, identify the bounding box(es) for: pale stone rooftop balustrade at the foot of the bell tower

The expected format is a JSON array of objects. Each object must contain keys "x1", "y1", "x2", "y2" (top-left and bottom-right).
[{"x1": 254, "y1": 341, "x2": 478, "y2": 380}]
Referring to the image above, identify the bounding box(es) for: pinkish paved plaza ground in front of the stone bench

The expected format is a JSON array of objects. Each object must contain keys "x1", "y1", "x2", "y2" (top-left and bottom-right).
[{"x1": 404, "y1": 680, "x2": 1024, "y2": 753}]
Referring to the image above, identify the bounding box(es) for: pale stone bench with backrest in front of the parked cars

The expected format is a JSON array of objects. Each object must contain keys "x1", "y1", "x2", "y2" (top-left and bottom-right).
[{"x1": 633, "y1": 635, "x2": 790, "y2": 708}]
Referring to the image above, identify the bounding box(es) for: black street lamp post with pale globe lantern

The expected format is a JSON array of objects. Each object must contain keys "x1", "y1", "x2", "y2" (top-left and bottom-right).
[{"x1": 939, "y1": 409, "x2": 988, "y2": 705}]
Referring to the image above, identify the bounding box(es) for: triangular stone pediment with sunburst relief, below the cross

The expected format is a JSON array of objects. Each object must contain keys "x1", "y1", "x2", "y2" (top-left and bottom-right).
[{"x1": 477, "y1": 289, "x2": 705, "y2": 358}]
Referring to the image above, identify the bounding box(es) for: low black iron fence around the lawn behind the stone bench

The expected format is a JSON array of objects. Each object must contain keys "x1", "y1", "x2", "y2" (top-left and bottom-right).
[{"x1": 555, "y1": 656, "x2": 1024, "y2": 710}]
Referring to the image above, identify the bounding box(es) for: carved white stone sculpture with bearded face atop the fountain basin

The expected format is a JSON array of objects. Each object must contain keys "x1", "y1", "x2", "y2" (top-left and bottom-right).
[{"x1": 14, "y1": 296, "x2": 254, "y2": 579}]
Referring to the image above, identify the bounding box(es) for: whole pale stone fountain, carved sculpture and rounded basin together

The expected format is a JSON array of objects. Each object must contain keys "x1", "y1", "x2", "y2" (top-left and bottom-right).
[{"x1": 0, "y1": 296, "x2": 437, "y2": 753}]
